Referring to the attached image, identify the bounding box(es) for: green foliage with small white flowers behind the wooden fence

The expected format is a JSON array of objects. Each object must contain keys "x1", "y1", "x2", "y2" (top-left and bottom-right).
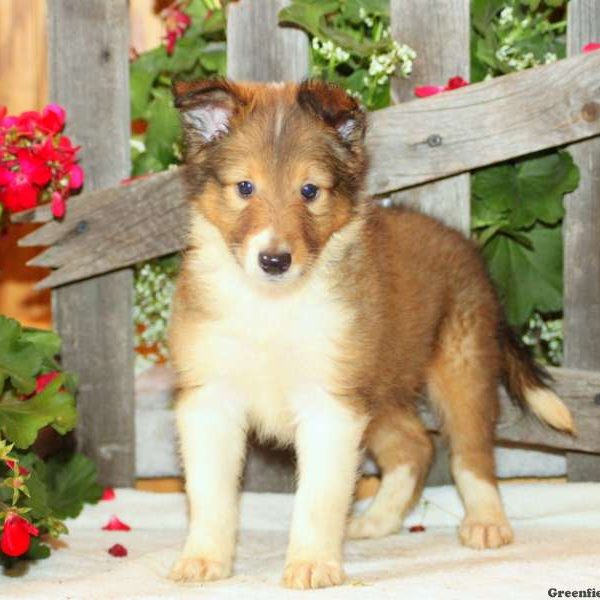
[{"x1": 131, "y1": 0, "x2": 579, "y2": 364}]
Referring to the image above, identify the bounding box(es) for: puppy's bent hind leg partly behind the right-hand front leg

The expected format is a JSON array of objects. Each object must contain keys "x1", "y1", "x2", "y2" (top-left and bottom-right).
[{"x1": 348, "y1": 408, "x2": 433, "y2": 538}]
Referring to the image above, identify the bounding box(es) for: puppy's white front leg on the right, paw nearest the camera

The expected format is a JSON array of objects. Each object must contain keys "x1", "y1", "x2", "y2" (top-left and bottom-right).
[{"x1": 283, "y1": 392, "x2": 366, "y2": 589}]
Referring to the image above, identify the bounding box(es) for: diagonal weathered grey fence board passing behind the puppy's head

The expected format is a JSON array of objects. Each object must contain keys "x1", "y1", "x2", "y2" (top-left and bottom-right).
[{"x1": 18, "y1": 52, "x2": 600, "y2": 287}]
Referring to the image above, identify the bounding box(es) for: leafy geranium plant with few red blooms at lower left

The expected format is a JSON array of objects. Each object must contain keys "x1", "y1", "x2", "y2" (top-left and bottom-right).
[{"x1": 0, "y1": 316, "x2": 102, "y2": 565}]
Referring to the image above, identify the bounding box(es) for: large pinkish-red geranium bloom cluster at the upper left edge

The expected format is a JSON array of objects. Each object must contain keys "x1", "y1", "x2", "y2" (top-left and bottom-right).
[{"x1": 0, "y1": 104, "x2": 84, "y2": 223}]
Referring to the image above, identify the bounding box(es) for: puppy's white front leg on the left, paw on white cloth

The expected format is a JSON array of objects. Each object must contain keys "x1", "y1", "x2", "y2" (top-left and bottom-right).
[{"x1": 170, "y1": 384, "x2": 246, "y2": 581}]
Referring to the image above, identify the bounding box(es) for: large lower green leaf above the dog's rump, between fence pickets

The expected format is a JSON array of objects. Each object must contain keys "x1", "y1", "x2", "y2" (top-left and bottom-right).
[{"x1": 483, "y1": 225, "x2": 563, "y2": 326}]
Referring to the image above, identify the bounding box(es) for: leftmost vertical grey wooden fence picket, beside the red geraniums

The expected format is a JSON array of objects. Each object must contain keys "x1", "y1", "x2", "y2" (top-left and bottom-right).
[{"x1": 48, "y1": 0, "x2": 135, "y2": 486}]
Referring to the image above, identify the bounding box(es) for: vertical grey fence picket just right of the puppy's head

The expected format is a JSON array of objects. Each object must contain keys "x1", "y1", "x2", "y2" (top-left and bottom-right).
[{"x1": 390, "y1": 0, "x2": 471, "y2": 234}]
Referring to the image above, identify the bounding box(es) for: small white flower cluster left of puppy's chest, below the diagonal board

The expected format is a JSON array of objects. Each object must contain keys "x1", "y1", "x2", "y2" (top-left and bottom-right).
[{"x1": 133, "y1": 261, "x2": 175, "y2": 360}]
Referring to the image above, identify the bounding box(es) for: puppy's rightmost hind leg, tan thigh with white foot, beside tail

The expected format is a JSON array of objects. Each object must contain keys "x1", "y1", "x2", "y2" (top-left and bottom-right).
[{"x1": 428, "y1": 315, "x2": 513, "y2": 549}]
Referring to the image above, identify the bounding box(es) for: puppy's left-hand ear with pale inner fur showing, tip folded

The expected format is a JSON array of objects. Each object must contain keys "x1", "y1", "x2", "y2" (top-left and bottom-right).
[{"x1": 173, "y1": 79, "x2": 245, "y2": 146}]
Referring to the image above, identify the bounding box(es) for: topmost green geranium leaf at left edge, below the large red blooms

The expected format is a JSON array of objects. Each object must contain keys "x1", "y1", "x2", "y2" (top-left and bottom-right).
[{"x1": 0, "y1": 315, "x2": 43, "y2": 394}]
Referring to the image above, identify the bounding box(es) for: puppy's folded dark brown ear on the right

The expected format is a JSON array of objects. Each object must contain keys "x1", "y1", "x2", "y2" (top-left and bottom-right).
[{"x1": 297, "y1": 79, "x2": 367, "y2": 146}]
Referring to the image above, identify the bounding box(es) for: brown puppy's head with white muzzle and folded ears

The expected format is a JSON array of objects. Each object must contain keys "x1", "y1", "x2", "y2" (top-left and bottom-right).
[{"x1": 175, "y1": 80, "x2": 367, "y2": 284}]
